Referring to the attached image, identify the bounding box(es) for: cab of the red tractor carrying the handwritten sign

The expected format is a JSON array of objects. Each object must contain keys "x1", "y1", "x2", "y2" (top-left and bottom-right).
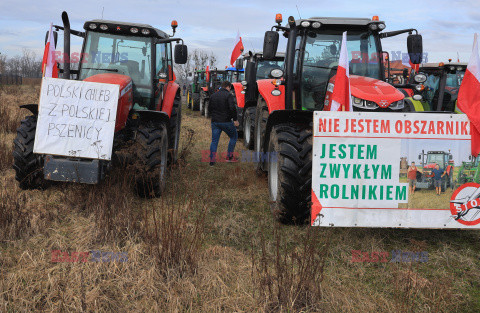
[{"x1": 78, "y1": 20, "x2": 187, "y2": 110}]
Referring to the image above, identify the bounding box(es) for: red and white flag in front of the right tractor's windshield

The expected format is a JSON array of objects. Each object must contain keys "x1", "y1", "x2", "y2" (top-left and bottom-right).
[{"x1": 330, "y1": 32, "x2": 352, "y2": 111}]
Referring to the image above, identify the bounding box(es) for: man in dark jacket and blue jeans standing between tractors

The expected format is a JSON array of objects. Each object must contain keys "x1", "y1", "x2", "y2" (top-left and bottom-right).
[{"x1": 208, "y1": 81, "x2": 239, "y2": 166}]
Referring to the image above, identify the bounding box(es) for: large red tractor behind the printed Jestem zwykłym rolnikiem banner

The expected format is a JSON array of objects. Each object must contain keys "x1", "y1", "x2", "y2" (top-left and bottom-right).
[{"x1": 254, "y1": 14, "x2": 423, "y2": 223}]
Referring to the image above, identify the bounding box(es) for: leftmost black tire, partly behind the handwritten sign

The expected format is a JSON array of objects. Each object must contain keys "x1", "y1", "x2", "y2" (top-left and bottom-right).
[{"x1": 13, "y1": 115, "x2": 46, "y2": 190}]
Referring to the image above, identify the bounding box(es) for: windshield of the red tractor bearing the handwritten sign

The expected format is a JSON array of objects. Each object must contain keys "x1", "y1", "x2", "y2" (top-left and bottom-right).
[{"x1": 79, "y1": 31, "x2": 153, "y2": 106}]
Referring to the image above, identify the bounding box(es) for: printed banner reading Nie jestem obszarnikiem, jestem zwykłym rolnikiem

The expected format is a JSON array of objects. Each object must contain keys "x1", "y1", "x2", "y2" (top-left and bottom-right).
[{"x1": 312, "y1": 112, "x2": 480, "y2": 229}]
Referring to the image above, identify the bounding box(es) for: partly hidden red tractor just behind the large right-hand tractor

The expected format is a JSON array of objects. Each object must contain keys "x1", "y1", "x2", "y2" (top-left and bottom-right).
[{"x1": 233, "y1": 52, "x2": 285, "y2": 150}]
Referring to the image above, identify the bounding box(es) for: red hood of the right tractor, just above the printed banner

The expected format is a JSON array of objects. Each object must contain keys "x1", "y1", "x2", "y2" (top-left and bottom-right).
[{"x1": 350, "y1": 75, "x2": 405, "y2": 108}]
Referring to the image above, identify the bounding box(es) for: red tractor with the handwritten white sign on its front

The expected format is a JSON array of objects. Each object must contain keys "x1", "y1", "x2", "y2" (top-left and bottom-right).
[{"x1": 13, "y1": 12, "x2": 187, "y2": 197}]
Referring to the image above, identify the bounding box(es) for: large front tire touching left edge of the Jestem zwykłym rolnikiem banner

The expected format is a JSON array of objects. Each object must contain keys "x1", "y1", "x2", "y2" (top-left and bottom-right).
[{"x1": 268, "y1": 124, "x2": 312, "y2": 224}]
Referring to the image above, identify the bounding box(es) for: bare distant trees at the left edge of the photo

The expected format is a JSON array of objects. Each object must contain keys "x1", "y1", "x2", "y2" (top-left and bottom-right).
[{"x1": 0, "y1": 49, "x2": 42, "y2": 78}]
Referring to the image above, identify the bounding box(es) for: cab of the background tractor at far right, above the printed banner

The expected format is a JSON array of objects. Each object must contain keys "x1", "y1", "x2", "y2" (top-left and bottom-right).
[{"x1": 411, "y1": 62, "x2": 467, "y2": 113}]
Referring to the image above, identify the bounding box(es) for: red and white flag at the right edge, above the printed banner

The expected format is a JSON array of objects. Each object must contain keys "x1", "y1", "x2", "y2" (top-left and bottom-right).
[{"x1": 457, "y1": 34, "x2": 480, "y2": 156}]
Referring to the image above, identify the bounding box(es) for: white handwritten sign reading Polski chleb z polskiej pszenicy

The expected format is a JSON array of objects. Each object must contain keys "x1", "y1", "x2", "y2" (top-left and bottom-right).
[{"x1": 33, "y1": 78, "x2": 119, "y2": 160}]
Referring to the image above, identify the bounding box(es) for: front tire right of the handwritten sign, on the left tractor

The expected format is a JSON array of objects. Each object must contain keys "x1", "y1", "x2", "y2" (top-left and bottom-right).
[{"x1": 135, "y1": 123, "x2": 168, "y2": 198}]
